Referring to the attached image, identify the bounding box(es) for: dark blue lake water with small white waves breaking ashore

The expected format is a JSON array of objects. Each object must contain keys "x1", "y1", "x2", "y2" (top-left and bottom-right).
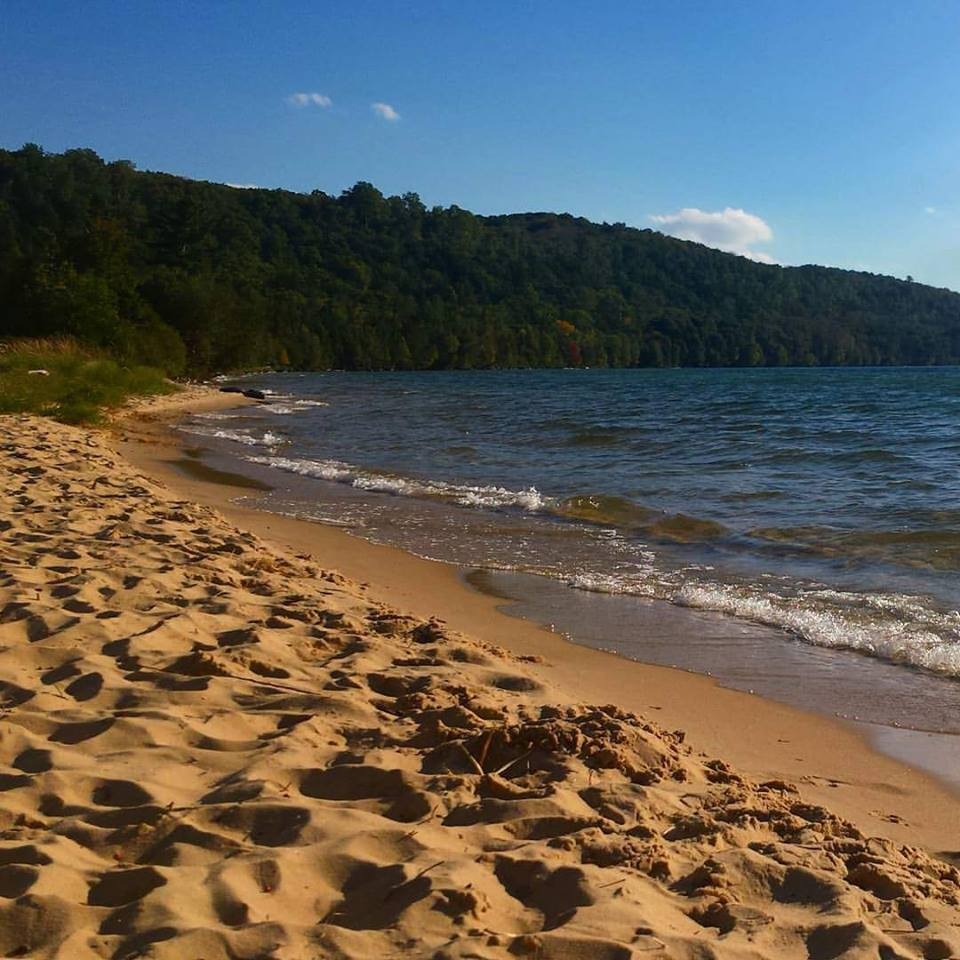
[{"x1": 183, "y1": 368, "x2": 960, "y2": 760}]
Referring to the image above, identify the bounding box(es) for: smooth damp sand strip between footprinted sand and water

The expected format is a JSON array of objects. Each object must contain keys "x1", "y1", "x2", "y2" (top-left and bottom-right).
[{"x1": 119, "y1": 394, "x2": 960, "y2": 856}]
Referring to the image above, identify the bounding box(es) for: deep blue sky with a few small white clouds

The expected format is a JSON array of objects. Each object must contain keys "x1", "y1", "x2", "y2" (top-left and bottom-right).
[{"x1": 0, "y1": 0, "x2": 960, "y2": 289}]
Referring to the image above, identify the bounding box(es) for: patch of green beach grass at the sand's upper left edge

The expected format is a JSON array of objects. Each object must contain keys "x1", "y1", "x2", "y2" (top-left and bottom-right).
[{"x1": 0, "y1": 337, "x2": 176, "y2": 423}]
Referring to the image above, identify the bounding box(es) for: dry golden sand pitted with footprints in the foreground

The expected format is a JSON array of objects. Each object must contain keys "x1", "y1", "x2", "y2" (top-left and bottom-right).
[{"x1": 0, "y1": 418, "x2": 960, "y2": 960}]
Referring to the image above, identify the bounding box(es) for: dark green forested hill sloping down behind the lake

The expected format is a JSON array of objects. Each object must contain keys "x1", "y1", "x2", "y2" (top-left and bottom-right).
[{"x1": 0, "y1": 145, "x2": 960, "y2": 374}]
